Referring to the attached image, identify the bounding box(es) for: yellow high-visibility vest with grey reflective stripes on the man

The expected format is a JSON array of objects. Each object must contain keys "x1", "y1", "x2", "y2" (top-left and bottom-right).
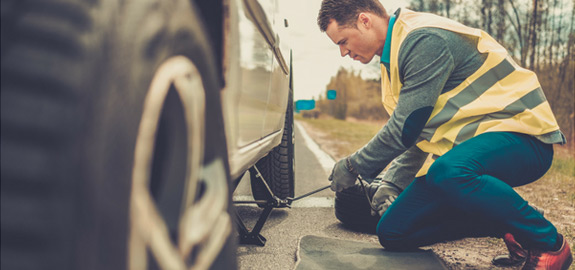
[{"x1": 381, "y1": 9, "x2": 559, "y2": 177}]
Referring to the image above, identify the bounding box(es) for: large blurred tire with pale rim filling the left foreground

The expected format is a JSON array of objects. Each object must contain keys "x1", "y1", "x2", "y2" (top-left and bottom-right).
[{"x1": 0, "y1": 0, "x2": 237, "y2": 269}]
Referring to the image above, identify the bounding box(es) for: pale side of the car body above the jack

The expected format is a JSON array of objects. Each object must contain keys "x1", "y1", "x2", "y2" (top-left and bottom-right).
[{"x1": 222, "y1": 0, "x2": 291, "y2": 179}]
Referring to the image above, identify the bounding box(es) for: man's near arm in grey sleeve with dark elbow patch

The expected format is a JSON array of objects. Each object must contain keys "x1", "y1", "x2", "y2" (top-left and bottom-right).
[{"x1": 349, "y1": 31, "x2": 455, "y2": 179}]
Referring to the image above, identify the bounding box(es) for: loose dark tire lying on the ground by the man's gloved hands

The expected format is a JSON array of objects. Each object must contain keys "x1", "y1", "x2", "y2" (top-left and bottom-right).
[{"x1": 334, "y1": 182, "x2": 380, "y2": 233}]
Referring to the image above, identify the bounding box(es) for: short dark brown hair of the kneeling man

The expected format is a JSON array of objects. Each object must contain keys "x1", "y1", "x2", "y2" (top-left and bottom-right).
[{"x1": 317, "y1": 0, "x2": 389, "y2": 32}]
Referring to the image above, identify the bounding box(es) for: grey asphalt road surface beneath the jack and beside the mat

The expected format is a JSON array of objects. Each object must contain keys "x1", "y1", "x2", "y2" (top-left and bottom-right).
[{"x1": 234, "y1": 122, "x2": 377, "y2": 270}]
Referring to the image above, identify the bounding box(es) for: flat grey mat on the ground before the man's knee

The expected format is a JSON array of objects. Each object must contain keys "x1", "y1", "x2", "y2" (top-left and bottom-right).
[{"x1": 295, "y1": 235, "x2": 447, "y2": 270}]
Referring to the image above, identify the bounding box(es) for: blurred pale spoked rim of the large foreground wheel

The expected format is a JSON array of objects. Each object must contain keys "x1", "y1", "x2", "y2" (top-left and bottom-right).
[{"x1": 128, "y1": 56, "x2": 231, "y2": 269}]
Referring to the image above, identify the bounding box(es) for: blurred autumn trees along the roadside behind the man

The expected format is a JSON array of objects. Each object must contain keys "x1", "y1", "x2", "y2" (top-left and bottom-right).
[{"x1": 317, "y1": 0, "x2": 575, "y2": 146}]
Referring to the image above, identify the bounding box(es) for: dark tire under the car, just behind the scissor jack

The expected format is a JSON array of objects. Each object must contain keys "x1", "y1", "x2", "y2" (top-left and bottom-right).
[{"x1": 250, "y1": 90, "x2": 295, "y2": 202}]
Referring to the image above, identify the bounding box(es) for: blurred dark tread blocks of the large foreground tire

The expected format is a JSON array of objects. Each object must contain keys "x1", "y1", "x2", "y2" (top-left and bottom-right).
[{"x1": 0, "y1": 1, "x2": 91, "y2": 269}]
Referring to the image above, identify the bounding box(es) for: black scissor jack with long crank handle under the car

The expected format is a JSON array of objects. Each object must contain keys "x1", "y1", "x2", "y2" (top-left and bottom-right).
[{"x1": 234, "y1": 165, "x2": 330, "y2": 247}]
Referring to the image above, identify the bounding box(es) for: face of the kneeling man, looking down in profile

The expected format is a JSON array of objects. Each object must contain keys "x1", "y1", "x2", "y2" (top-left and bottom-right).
[{"x1": 325, "y1": 15, "x2": 380, "y2": 64}]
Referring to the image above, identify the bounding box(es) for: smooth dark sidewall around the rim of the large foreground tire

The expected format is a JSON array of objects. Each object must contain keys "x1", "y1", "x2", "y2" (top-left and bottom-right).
[{"x1": 78, "y1": 0, "x2": 233, "y2": 269}]
